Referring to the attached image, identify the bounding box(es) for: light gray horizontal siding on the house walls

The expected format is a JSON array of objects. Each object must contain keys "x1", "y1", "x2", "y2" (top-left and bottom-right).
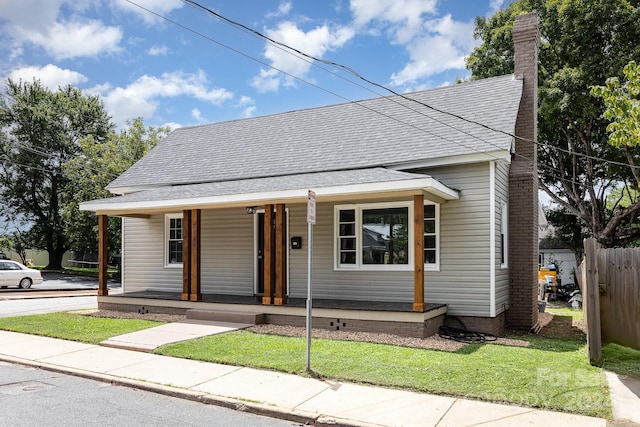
[{"x1": 124, "y1": 163, "x2": 500, "y2": 316}]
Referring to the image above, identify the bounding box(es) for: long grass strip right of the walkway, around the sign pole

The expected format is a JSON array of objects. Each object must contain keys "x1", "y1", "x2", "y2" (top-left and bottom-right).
[{"x1": 156, "y1": 331, "x2": 611, "y2": 418}]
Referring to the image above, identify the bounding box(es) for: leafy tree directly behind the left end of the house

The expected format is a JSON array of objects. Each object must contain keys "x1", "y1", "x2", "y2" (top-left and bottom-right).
[{"x1": 63, "y1": 118, "x2": 170, "y2": 254}]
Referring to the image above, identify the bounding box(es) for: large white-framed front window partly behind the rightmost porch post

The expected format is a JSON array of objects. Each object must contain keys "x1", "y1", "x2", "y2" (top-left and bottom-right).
[{"x1": 334, "y1": 202, "x2": 440, "y2": 270}]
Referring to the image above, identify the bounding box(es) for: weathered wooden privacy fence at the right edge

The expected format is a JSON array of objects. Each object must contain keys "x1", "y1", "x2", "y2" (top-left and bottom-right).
[{"x1": 577, "y1": 239, "x2": 640, "y2": 365}]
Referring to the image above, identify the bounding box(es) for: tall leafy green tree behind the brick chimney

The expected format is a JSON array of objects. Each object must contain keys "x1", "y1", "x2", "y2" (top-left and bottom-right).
[{"x1": 467, "y1": 0, "x2": 640, "y2": 249}]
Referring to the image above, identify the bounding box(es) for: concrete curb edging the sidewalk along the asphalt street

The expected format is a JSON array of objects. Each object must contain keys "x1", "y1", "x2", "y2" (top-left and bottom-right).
[{"x1": 0, "y1": 355, "x2": 375, "y2": 427}]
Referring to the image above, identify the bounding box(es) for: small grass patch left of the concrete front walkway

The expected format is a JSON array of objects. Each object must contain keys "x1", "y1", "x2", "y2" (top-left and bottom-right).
[{"x1": 0, "y1": 312, "x2": 166, "y2": 344}]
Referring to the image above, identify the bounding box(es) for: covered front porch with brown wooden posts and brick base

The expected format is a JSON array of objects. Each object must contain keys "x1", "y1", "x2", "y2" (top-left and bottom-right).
[{"x1": 83, "y1": 168, "x2": 459, "y2": 336}]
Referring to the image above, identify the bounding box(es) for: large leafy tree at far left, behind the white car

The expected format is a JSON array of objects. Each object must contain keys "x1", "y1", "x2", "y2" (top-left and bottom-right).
[{"x1": 0, "y1": 79, "x2": 113, "y2": 269}]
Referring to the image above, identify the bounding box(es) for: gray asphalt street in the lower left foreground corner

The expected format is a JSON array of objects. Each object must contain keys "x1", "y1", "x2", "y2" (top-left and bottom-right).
[{"x1": 0, "y1": 362, "x2": 299, "y2": 427}]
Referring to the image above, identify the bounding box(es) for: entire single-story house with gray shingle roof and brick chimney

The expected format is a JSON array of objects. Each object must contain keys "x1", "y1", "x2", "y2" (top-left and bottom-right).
[{"x1": 81, "y1": 14, "x2": 538, "y2": 336}]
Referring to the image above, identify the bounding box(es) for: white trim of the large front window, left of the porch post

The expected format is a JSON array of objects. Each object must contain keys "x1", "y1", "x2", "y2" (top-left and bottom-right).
[{"x1": 333, "y1": 202, "x2": 414, "y2": 271}]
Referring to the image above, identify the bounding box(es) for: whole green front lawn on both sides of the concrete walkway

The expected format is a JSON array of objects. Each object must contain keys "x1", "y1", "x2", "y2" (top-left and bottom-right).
[{"x1": 0, "y1": 309, "x2": 640, "y2": 418}]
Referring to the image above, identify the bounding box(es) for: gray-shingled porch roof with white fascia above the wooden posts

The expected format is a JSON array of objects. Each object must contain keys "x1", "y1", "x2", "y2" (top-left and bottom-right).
[{"x1": 80, "y1": 168, "x2": 459, "y2": 216}]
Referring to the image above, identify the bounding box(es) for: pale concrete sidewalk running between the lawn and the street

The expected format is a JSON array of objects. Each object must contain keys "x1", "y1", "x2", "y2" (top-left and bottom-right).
[{"x1": 0, "y1": 331, "x2": 624, "y2": 427}]
